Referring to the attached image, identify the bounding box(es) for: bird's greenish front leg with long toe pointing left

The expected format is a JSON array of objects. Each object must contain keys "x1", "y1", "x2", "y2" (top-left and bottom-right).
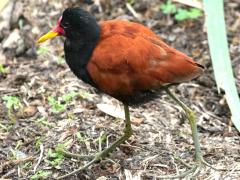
[{"x1": 56, "y1": 104, "x2": 133, "y2": 179}]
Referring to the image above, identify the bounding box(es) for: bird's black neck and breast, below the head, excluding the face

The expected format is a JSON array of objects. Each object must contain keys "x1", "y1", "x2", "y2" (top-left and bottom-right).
[{"x1": 64, "y1": 30, "x2": 100, "y2": 87}]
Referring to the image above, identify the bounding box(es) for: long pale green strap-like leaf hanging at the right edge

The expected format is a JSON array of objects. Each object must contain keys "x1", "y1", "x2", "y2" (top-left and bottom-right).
[{"x1": 203, "y1": 0, "x2": 240, "y2": 132}]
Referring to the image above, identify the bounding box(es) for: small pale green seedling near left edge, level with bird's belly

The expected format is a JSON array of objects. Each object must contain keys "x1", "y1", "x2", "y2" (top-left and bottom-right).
[{"x1": 2, "y1": 96, "x2": 23, "y2": 121}]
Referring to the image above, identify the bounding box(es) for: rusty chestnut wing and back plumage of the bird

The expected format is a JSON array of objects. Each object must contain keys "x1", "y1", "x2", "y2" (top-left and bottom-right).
[{"x1": 87, "y1": 21, "x2": 201, "y2": 95}]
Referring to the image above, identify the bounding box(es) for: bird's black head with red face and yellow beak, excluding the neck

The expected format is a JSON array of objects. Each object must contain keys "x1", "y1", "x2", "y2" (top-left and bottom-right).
[{"x1": 38, "y1": 7, "x2": 100, "y2": 43}]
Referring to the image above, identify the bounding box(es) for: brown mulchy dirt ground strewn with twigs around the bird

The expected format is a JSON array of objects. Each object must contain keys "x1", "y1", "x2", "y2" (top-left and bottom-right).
[{"x1": 0, "y1": 0, "x2": 240, "y2": 180}]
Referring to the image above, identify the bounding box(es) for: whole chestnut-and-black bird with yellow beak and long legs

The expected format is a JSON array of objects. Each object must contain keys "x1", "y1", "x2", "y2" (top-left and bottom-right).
[{"x1": 38, "y1": 7, "x2": 205, "y2": 177}]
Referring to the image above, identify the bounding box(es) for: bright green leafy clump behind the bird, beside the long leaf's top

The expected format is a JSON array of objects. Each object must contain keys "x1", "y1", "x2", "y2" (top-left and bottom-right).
[{"x1": 160, "y1": 0, "x2": 202, "y2": 21}]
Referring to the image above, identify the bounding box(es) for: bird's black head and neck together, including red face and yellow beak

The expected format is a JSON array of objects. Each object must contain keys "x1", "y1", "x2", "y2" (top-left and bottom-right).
[{"x1": 38, "y1": 8, "x2": 100, "y2": 86}]
